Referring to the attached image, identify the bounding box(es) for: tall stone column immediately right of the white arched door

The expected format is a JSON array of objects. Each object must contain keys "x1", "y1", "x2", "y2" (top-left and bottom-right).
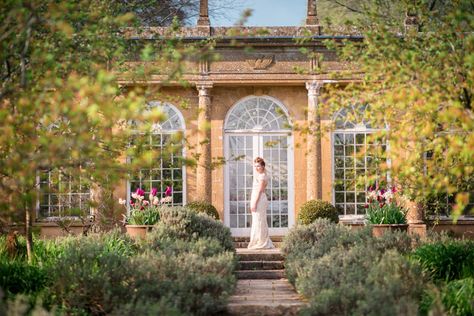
[{"x1": 306, "y1": 81, "x2": 323, "y2": 200}]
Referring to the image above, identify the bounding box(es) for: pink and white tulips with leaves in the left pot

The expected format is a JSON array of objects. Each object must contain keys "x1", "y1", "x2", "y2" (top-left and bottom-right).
[{"x1": 119, "y1": 186, "x2": 173, "y2": 225}]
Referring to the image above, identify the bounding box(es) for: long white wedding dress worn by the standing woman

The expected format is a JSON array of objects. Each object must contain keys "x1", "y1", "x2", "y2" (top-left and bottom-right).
[{"x1": 247, "y1": 173, "x2": 275, "y2": 249}]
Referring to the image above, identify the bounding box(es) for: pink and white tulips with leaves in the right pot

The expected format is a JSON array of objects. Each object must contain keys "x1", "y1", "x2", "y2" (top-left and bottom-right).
[{"x1": 366, "y1": 187, "x2": 407, "y2": 224}]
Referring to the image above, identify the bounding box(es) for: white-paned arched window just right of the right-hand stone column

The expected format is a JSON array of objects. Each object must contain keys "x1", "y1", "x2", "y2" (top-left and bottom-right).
[{"x1": 332, "y1": 105, "x2": 389, "y2": 215}]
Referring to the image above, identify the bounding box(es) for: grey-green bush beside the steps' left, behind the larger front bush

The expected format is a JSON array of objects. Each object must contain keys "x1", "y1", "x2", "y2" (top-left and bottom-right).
[{"x1": 154, "y1": 207, "x2": 234, "y2": 250}]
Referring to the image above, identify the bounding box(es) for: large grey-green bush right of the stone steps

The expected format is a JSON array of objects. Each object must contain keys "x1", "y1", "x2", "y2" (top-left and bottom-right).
[{"x1": 282, "y1": 219, "x2": 424, "y2": 315}]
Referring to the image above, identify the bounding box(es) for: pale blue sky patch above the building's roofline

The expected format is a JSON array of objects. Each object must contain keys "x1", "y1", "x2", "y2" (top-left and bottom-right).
[{"x1": 210, "y1": 0, "x2": 308, "y2": 26}]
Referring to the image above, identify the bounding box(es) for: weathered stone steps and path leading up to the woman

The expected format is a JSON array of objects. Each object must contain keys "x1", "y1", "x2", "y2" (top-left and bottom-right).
[{"x1": 227, "y1": 237, "x2": 306, "y2": 316}]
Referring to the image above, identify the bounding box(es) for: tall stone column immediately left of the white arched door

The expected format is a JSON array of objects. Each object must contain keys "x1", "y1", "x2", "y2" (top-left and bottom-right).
[{"x1": 196, "y1": 83, "x2": 212, "y2": 203}]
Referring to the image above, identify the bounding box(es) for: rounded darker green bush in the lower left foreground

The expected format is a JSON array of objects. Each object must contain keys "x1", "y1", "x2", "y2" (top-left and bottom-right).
[{"x1": 45, "y1": 237, "x2": 135, "y2": 315}]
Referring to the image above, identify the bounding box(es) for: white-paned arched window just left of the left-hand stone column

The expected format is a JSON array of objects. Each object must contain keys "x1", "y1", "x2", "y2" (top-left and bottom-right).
[{"x1": 127, "y1": 101, "x2": 185, "y2": 205}]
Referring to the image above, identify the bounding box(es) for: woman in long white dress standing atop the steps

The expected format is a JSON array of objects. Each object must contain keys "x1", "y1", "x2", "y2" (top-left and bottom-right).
[{"x1": 247, "y1": 157, "x2": 274, "y2": 249}]
